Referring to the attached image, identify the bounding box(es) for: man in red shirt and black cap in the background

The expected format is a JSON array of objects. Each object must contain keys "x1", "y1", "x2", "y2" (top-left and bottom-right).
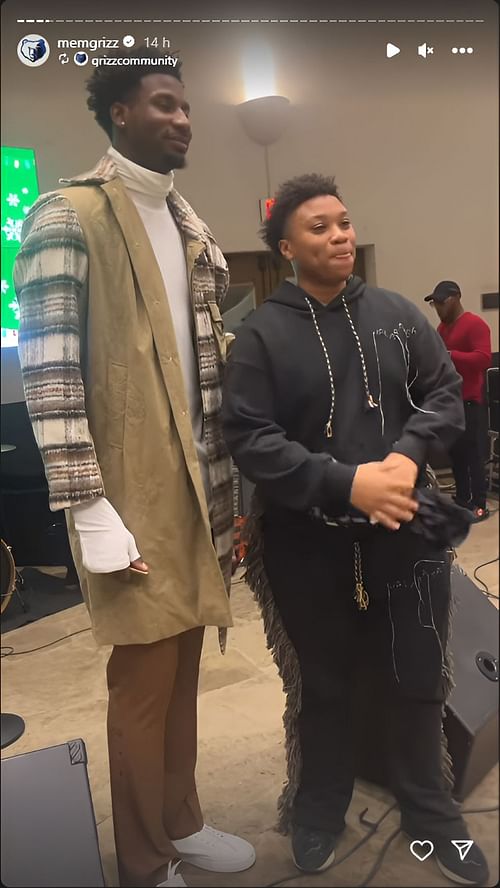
[{"x1": 425, "y1": 281, "x2": 491, "y2": 521}]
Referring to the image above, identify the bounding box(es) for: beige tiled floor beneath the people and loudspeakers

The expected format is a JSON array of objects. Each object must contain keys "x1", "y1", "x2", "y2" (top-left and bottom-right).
[{"x1": 2, "y1": 503, "x2": 498, "y2": 888}]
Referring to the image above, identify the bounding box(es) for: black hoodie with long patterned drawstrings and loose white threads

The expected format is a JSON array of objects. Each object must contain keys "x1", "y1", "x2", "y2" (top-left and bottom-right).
[{"x1": 223, "y1": 277, "x2": 464, "y2": 517}]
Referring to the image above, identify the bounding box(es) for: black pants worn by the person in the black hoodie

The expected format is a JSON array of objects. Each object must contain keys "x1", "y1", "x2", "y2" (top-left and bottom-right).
[{"x1": 264, "y1": 514, "x2": 467, "y2": 839}]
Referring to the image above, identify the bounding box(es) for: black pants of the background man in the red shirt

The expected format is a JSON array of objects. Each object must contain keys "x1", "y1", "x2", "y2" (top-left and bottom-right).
[{"x1": 450, "y1": 401, "x2": 487, "y2": 509}]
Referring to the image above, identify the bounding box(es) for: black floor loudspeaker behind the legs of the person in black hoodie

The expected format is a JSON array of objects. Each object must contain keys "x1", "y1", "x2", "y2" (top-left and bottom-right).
[{"x1": 354, "y1": 566, "x2": 499, "y2": 801}]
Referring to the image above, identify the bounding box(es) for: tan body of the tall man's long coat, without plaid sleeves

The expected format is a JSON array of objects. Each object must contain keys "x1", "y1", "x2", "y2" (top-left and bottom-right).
[{"x1": 64, "y1": 179, "x2": 232, "y2": 644}]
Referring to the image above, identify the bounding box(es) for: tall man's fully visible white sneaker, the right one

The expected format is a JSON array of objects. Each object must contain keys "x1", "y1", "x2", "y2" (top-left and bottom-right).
[{"x1": 172, "y1": 826, "x2": 255, "y2": 873}]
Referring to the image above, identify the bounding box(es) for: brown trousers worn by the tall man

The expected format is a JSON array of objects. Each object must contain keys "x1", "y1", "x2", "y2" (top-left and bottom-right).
[{"x1": 107, "y1": 627, "x2": 204, "y2": 888}]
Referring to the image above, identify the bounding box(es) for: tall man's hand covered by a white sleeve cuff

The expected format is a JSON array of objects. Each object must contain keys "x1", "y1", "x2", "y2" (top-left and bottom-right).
[{"x1": 71, "y1": 496, "x2": 149, "y2": 574}]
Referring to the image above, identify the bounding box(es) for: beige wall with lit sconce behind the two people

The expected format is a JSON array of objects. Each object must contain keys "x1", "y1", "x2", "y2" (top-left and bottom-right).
[{"x1": 2, "y1": 6, "x2": 498, "y2": 348}]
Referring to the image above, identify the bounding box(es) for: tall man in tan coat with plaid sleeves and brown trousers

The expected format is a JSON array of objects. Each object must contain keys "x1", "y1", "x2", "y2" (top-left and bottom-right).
[{"x1": 15, "y1": 51, "x2": 255, "y2": 886}]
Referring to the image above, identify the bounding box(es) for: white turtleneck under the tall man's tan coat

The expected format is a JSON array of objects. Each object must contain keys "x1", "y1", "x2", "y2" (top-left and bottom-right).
[{"x1": 108, "y1": 147, "x2": 211, "y2": 506}]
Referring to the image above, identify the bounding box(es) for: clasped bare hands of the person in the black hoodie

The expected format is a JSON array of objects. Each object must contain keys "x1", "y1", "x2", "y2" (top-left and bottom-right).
[{"x1": 351, "y1": 462, "x2": 418, "y2": 530}]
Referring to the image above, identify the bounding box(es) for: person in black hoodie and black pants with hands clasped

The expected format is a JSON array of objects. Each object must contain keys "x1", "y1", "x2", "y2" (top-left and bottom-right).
[{"x1": 223, "y1": 175, "x2": 488, "y2": 885}]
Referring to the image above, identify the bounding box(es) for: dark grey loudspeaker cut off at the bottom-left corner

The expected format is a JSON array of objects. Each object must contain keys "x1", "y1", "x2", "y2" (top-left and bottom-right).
[{"x1": 1, "y1": 740, "x2": 104, "y2": 888}]
